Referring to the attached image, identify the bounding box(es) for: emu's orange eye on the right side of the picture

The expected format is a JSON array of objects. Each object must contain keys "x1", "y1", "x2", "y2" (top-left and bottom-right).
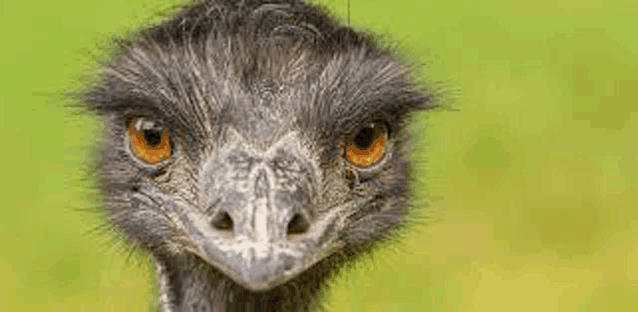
[{"x1": 346, "y1": 122, "x2": 388, "y2": 167}]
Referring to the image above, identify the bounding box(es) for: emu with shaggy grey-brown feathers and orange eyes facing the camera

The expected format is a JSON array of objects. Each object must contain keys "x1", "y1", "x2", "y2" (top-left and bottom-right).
[{"x1": 85, "y1": 0, "x2": 432, "y2": 312}]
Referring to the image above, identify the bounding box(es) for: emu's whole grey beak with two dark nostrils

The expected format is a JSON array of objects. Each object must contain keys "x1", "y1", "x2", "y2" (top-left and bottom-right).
[{"x1": 174, "y1": 130, "x2": 350, "y2": 291}]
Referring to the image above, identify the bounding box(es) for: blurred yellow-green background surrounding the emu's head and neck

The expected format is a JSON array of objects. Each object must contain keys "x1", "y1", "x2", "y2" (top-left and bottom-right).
[{"x1": 0, "y1": 0, "x2": 638, "y2": 311}]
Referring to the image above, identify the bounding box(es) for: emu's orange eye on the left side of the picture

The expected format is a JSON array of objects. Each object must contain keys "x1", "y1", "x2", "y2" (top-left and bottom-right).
[{"x1": 128, "y1": 117, "x2": 171, "y2": 165}]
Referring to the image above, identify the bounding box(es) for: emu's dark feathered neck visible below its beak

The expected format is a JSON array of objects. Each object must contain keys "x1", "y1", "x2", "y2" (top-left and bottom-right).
[{"x1": 156, "y1": 255, "x2": 334, "y2": 312}]
